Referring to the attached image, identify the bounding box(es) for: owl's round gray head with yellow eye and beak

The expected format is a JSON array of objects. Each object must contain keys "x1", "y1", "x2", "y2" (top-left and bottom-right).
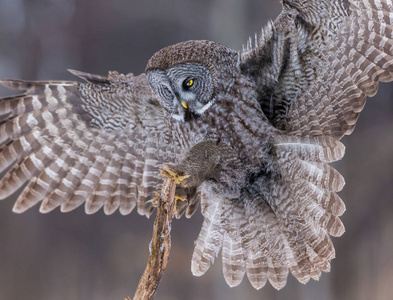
[{"x1": 146, "y1": 41, "x2": 238, "y2": 122}]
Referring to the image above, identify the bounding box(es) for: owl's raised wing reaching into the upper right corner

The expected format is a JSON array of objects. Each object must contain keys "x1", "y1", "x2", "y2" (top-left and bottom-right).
[{"x1": 242, "y1": 0, "x2": 393, "y2": 139}]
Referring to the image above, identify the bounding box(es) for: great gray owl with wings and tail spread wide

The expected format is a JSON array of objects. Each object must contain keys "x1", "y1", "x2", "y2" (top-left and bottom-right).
[{"x1": 0, "y1": 0, "x2": 393, "y2": 289}]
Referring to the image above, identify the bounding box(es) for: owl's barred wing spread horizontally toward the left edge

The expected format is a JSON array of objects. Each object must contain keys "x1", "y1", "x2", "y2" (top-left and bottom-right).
[{"x1": 0, "y1": 71, "x2": 179, "y2": 216}]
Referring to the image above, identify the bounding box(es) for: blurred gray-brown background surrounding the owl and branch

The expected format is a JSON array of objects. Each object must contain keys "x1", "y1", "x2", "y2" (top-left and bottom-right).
[{"x1": 0, "y1": 0, "x2": 393, "y2": 300}]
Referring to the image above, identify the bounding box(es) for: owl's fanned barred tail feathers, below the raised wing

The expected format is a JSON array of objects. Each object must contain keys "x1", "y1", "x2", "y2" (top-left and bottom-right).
[{"x1": 192, "y1": 136, "x2": 345, "y2": 289}]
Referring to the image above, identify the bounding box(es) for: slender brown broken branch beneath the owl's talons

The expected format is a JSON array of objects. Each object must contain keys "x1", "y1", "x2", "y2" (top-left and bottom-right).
[{"x1": 127, "y1": 178, "x2": 176, "y2": 300}]
